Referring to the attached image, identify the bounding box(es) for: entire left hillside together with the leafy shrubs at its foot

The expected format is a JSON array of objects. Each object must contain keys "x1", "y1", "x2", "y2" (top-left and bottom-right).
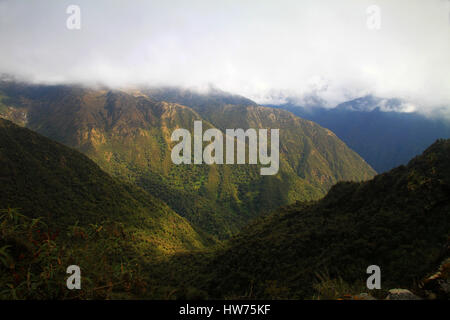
[{"x1": 0, "y1": 119, "x2": 215, "y2": 299}]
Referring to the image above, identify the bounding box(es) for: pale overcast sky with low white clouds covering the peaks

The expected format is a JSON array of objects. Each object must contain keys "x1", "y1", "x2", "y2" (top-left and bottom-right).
[{"x1": 0, "y1": 0, "x2": 450, "y2": 110}]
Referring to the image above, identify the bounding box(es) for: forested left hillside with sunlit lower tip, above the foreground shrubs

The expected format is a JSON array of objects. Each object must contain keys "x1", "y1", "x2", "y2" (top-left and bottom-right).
[{"x1": 0, "y1": 119, "x2": 209, "y2": 253}]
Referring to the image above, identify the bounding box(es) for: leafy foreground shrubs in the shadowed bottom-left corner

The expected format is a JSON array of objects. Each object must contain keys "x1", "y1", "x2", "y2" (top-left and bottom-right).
[{"x1": 0, "y1": 209, "x2": 151, "y2": 299}]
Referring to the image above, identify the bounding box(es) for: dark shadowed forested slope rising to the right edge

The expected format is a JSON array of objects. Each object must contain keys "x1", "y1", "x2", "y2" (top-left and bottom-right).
[{"x1": 163, "y1": 140, "x2": 450, "y2": 298}]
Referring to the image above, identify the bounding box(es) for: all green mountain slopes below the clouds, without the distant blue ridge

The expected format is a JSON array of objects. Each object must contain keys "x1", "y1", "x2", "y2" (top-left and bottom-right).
[{"x1": 0, "y1": 82, "x2": 450, "y2": 299}]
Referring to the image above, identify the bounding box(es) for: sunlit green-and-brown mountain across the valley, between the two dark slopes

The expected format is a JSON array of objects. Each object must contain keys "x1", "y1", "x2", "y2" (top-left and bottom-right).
[{"x1": 0, "y1": 83, "x2": 375, "y2": 238}]
